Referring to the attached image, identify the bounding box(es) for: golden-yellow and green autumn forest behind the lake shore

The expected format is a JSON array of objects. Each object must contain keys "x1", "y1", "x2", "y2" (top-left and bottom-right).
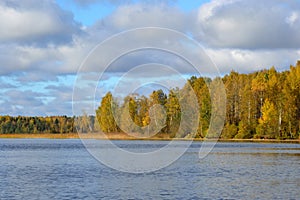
[{"x1": 0, "y1": 61, "x2": 300, "y2": 139}]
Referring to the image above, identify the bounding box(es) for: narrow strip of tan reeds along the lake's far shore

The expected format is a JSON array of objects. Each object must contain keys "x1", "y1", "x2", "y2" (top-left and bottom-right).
[{"x1": 0, "y1": 133, "x2": 300, "y2": 144}]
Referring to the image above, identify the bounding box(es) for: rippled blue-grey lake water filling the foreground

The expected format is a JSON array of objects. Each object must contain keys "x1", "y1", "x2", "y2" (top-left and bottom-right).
[{"x1": 0, "y1": 139, "x2": 300, "y2": 199}]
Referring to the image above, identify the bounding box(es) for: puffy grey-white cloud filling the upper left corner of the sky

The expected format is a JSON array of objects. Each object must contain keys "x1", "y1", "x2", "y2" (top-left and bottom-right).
[{"x1": 0, "y1": 0, "x2": 81, "y2": 46}]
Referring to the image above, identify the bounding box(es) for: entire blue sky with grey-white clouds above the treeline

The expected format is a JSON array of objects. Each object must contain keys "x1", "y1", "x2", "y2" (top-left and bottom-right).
[{"x1": 0, "y1": 0, "x2": 300, "y2": 116}]
